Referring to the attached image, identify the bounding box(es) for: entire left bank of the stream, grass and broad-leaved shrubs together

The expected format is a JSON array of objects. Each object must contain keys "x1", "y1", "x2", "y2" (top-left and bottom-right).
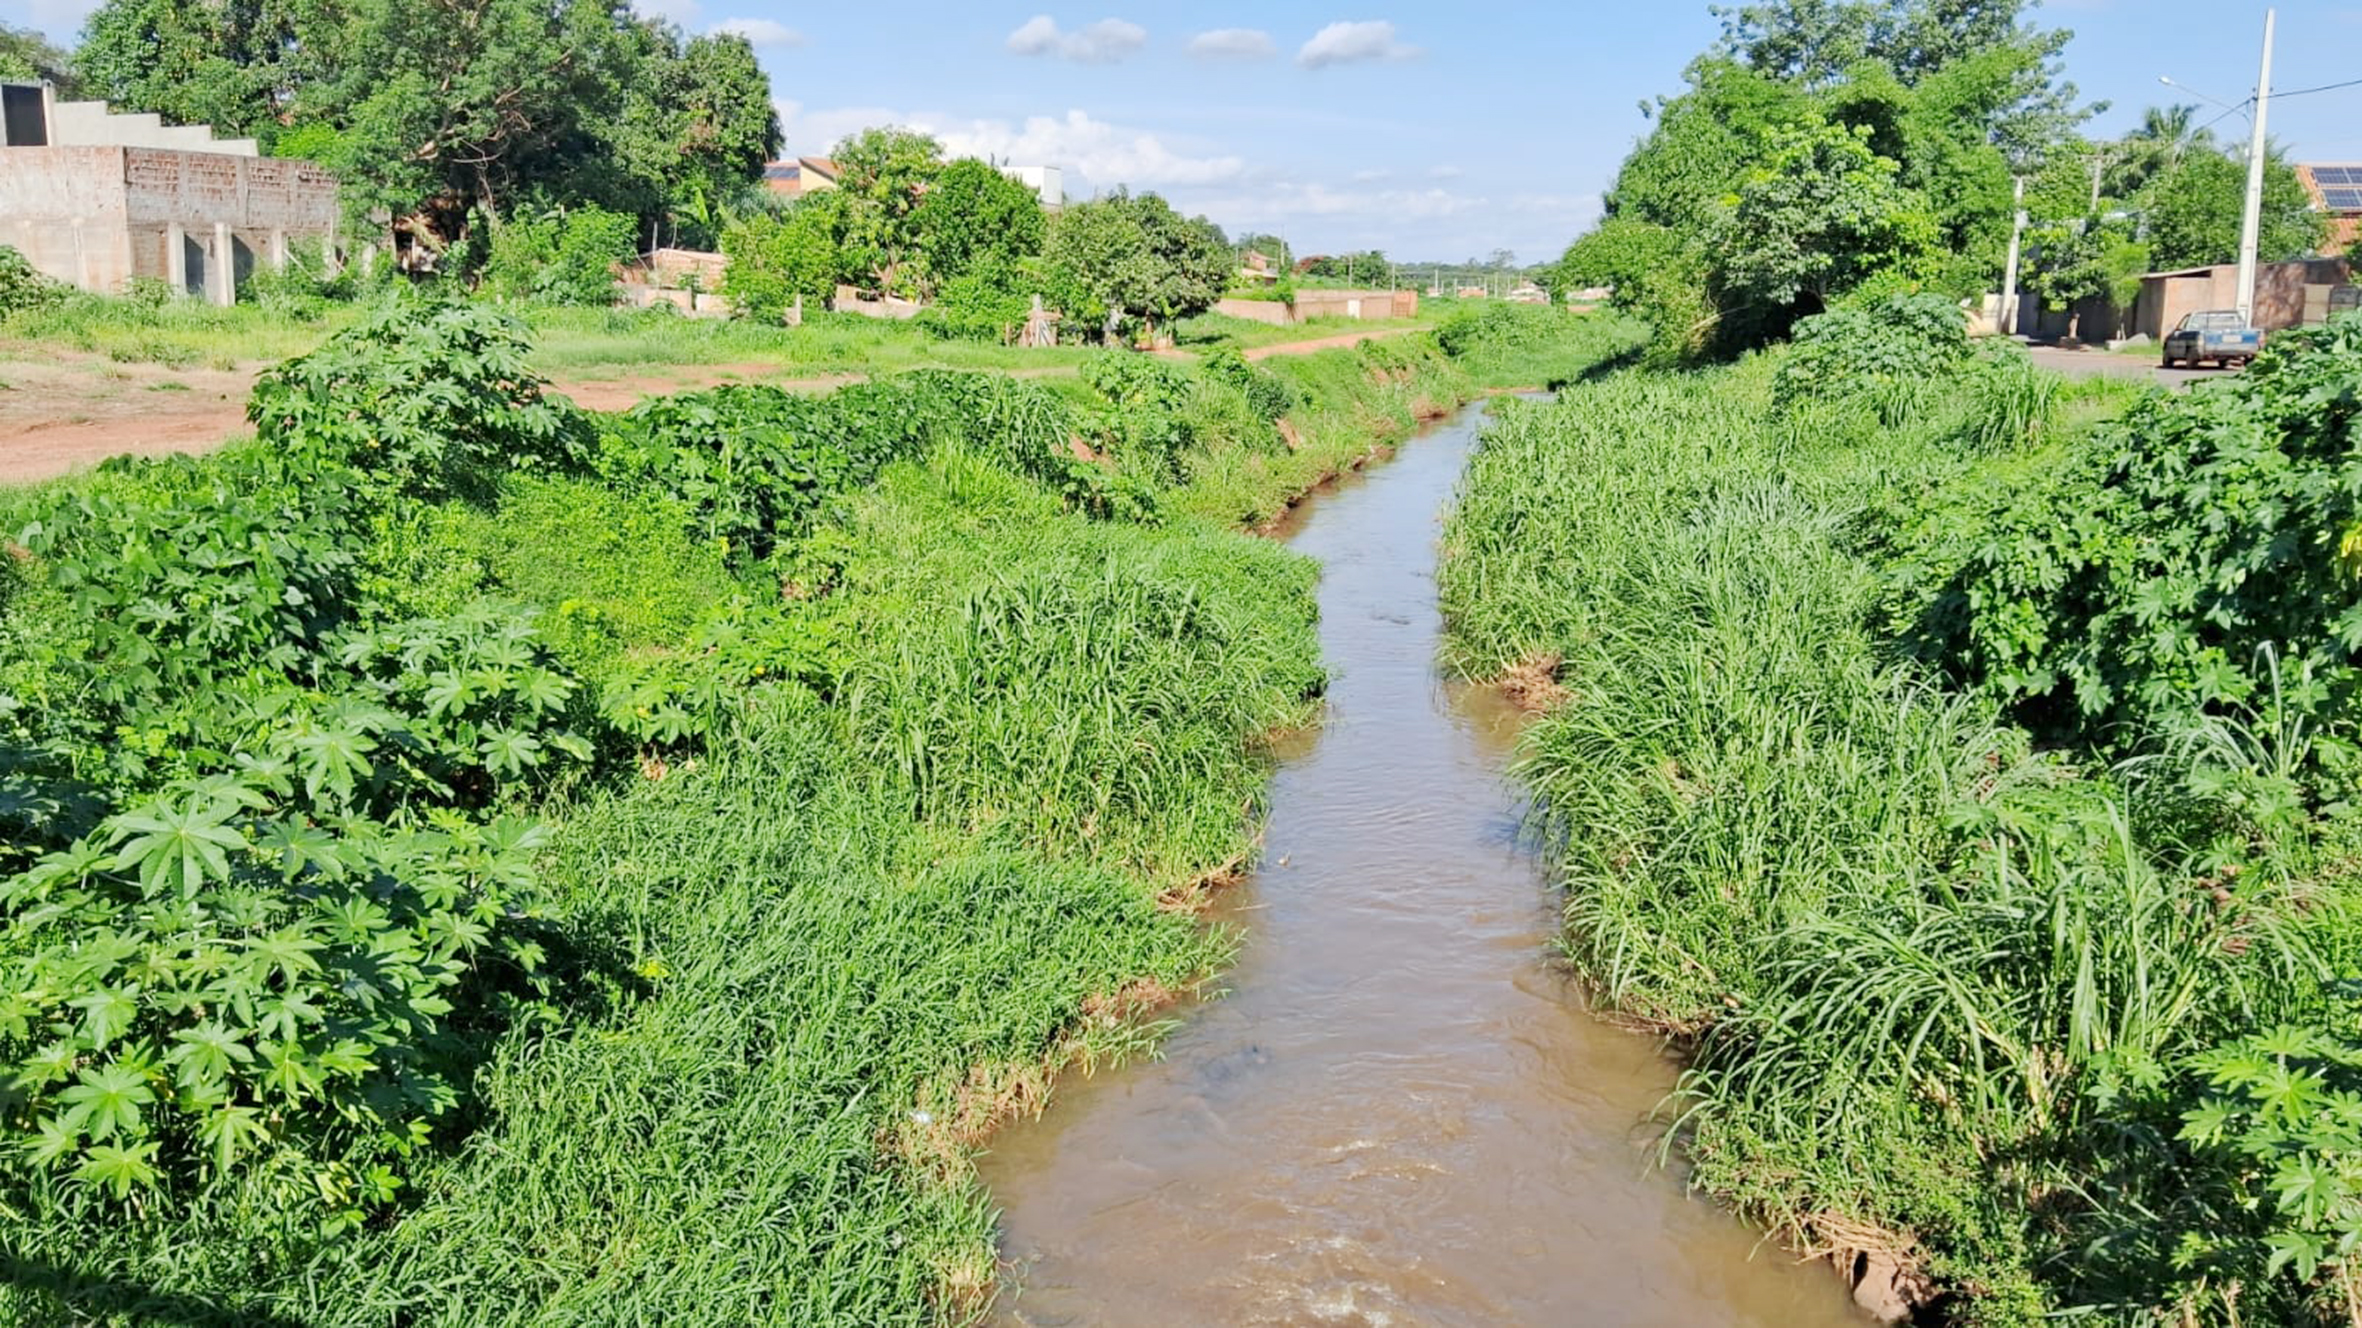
[{"x1": 0, "y1": 294, "x2": 1625, "y2": 1326}]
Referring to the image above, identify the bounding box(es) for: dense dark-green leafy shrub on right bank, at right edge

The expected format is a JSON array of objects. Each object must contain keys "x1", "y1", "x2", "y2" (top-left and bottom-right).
[{"x1": 1913, "y1": 319, "x2": 2362, "y2": 761}]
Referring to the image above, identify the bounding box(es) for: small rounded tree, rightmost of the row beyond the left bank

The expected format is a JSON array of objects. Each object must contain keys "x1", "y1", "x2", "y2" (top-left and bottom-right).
[{"x1": 1044, "y1": 189, "x2": 1231, "y2": 340}]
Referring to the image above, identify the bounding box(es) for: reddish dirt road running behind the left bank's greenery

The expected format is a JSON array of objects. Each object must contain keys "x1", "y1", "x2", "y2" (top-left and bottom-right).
[{"x1": 0, "y1": 328, "x2": 1417, "y2": 484}]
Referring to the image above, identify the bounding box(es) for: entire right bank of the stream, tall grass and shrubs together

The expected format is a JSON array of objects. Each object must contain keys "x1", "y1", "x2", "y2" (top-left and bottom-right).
[{"x1": 1443, "y1": 302, "x2": 2362, "y2": 1323}]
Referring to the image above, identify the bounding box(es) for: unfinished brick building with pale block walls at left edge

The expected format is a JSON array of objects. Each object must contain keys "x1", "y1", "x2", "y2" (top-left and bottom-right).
[{"x1": 0, "y1": 83, "x2": 338, "y2": 305}]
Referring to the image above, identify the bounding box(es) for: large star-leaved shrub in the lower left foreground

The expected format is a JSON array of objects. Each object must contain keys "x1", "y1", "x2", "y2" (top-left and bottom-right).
[{"x1": 0, "y1": 770, "x2": 543, "y2": 1224}]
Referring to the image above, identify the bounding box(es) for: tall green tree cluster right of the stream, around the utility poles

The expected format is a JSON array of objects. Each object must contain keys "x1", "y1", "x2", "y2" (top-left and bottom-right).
[{"x1": 1554, "y1": 0, "x2": 2322, "y2": 366}]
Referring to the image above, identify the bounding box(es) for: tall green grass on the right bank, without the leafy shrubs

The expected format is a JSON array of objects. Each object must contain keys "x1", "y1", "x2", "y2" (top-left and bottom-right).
[{"x1": 1441, "y1": 352, "x2": 2350, "y2": 1323}]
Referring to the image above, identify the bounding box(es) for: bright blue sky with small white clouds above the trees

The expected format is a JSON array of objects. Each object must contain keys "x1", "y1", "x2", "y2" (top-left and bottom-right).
[{"x1": 18, "y1": 0, "x2": 2362, "y2": 260}]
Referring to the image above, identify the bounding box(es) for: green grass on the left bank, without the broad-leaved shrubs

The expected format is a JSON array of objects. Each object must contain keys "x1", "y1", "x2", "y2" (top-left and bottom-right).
[{"x1": 0, "y1": 307, "x2": 1511, "y2": 1326}]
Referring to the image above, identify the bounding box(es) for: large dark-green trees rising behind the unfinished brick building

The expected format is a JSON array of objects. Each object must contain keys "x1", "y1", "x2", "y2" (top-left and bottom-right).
[{"x1": 73, "y1": 0, "x2": 779, "y2": 250}]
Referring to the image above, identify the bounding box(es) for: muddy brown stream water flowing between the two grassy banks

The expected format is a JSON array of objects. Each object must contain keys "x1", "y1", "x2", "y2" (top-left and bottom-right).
[{"x1": 983, "y1": 411, "x2": 1868, "y2": 1328}]
